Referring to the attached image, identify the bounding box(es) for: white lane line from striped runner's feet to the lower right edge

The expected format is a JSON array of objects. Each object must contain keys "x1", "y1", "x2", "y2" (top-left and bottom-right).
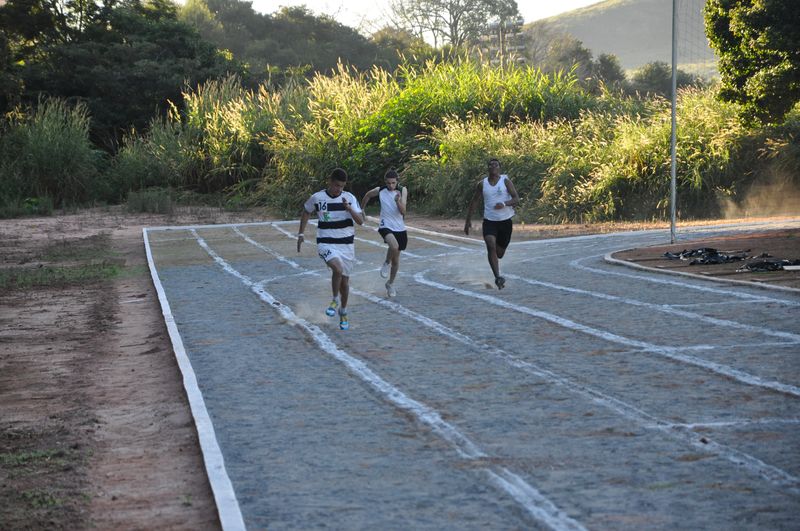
[{"x1": 351, "y1": 290, "x2": 800, "y2": 492}]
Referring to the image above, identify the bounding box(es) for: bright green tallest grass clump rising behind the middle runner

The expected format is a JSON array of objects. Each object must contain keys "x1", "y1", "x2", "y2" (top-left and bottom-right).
[{"x1": 260, "y1": 60, "x2": 593, "y2": 213}]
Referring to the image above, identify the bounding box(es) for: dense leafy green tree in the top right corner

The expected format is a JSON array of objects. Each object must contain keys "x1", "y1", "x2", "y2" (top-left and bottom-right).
[{"x1": 705, "y1": 0, "x2": 800, "y2": 123}]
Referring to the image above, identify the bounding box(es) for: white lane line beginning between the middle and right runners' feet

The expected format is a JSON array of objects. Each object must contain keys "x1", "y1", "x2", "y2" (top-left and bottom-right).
[{"x1": 414, "y1": 271, "x2": 800, "y2": 397}]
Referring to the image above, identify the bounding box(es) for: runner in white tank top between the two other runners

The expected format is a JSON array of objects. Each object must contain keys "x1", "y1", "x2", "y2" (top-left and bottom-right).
[{"x1": 361, "y1": 169, "x2": 408, "y2": 297}]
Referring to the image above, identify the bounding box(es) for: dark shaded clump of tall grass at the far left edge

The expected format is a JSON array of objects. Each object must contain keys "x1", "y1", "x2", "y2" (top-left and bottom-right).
[{"x1": 0, "y1": 99, "x2": 104, "y2": 211}]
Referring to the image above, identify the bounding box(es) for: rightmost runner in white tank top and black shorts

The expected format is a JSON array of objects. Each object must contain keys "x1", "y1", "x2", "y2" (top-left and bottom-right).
[{"x1": 464, "y1": 159, "x2": 519, "y2": 289}]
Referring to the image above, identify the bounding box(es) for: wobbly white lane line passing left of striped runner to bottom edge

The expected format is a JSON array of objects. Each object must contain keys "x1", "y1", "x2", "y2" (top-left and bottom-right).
[{"x1": 192, "y1": 230, "x2": 584, "y2": 530}]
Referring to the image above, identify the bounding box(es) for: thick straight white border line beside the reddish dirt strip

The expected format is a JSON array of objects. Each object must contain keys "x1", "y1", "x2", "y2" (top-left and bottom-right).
[{"x1": 142, "y1": 228, "x2": 245, "y2": 531}]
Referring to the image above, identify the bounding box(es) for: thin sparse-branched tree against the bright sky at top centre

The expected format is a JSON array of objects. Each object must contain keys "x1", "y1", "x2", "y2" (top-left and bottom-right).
[{"x1": 391, "y1": 0, "x2": 519, "y2": 48}]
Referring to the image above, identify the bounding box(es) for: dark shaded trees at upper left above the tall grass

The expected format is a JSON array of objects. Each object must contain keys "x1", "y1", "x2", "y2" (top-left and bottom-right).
[{"x1": 0, "y1": 0, "x2": 433, "y2": 148}]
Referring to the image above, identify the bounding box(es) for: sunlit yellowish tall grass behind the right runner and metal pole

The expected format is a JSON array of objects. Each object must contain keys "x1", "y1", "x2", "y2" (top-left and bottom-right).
[{"x1": 404, "y1": 88, "x2": 746, "y2": 222}]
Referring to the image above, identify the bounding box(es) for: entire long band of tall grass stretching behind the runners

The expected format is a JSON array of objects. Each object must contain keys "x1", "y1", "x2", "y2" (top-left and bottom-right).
[{"x1": 0, "y1": 60, "x2": 800, "y2": 222}]
